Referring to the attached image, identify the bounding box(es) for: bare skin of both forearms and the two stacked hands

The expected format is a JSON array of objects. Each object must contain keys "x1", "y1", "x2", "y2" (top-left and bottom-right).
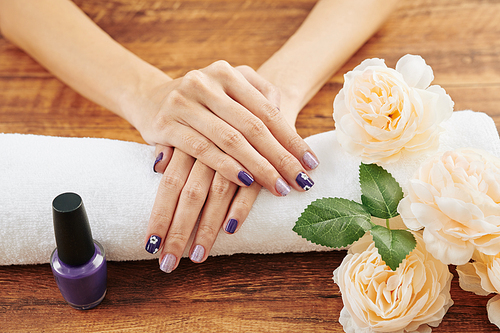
[{"x1": 0, "y1": 0, "x2": 396, "y2": 272}]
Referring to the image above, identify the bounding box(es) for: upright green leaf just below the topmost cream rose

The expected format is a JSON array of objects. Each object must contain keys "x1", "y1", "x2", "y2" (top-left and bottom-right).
[{"x1": 359, "y1": 163, "x2": 403, "y2": 219}]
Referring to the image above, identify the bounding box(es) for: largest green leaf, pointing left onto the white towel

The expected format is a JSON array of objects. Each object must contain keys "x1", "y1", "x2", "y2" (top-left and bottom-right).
[{"x1": 293, "y1": 198, "x2": 373, "y2": 248}]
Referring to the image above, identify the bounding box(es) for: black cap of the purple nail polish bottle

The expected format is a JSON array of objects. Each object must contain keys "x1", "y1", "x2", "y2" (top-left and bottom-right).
[{"x1": 52, "y1": 193, "x2": 95, "y2": 266}]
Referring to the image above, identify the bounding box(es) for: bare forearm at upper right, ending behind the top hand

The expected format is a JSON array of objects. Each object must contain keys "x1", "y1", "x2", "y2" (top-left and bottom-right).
[{"x1": 257, "y1": 0, "x2": 397, "y2": 124}]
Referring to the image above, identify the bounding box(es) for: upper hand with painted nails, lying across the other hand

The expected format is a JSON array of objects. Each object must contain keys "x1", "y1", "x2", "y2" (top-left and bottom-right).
[{"x1": 135, "y1": 61, "x2": 318, "y2": 196}]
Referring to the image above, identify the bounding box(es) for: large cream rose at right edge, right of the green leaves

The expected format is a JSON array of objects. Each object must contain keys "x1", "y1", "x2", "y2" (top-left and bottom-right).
[{"x1": 398, "y1": 149, "x2": 500, "y2": 265}]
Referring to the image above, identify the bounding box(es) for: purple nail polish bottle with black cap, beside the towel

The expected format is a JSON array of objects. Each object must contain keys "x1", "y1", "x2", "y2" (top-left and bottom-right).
[{"x1": 50, "y1": 193, "x2": 107, "y2": 310}]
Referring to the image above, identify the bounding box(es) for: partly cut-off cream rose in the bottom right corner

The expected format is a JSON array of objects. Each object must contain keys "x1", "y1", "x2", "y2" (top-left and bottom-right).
[{"x1": 457, "y1": 251, "x2": 500, "y2": 328}]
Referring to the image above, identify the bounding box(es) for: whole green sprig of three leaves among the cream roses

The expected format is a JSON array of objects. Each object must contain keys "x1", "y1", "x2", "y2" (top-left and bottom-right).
[{"x1": 293, "y1": 163, "x2": 416, "y2": 270}]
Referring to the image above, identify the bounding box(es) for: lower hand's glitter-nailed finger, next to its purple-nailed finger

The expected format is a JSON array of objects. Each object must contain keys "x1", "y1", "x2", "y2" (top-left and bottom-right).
[{"x1": 189, "y1": 173, "x2": 239, "y2": 263}]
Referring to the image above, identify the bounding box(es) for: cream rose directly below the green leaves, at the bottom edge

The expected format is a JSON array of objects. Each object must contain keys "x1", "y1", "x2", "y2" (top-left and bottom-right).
[{"x1": 333, "y1": 233, "x2": 453, "y2": 333}]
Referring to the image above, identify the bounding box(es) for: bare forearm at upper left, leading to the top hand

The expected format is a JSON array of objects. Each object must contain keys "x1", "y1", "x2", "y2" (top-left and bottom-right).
[{"x1": 0, "y1": 0, "x2": 170, "y2": 126}]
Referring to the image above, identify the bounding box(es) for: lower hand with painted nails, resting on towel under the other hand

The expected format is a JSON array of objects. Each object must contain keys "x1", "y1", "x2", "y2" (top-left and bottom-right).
[{"x1": 146, "y1": 145, "x2": 261, "y2": 273}]
